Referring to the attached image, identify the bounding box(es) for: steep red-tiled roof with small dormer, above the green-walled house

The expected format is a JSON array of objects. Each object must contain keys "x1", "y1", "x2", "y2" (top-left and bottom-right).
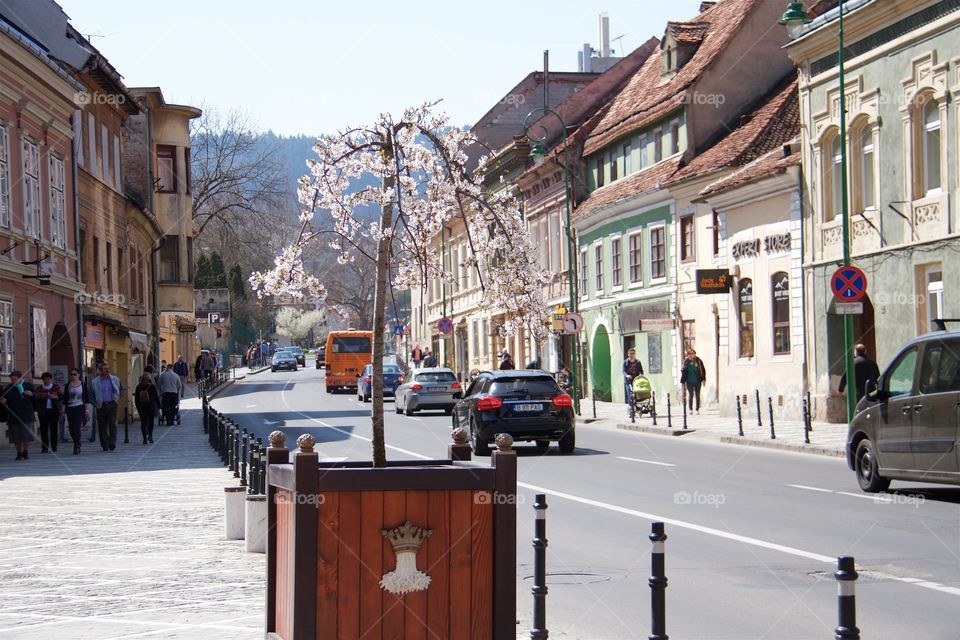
[{"x1": 583, "y1": 0, "x2": 769, "y2": 155}]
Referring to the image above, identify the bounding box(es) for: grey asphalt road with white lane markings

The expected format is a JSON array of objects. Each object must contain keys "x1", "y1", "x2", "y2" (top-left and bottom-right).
[{"x1": 214, "y1": 360, "x2": 960, "y2": 640}]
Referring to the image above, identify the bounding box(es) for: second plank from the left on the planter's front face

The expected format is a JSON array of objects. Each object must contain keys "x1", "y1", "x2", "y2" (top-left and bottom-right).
[{"x1": 337, "y1": 491, "x2": 360, "y2": 640}]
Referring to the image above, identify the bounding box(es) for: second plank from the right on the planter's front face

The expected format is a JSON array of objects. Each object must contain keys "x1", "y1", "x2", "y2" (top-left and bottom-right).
[{"x1": 449, "y1": 491, "x2": 474, "y2": 638}]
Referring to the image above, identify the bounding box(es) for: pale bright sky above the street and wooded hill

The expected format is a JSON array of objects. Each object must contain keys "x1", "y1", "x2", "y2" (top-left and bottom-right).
[{"x1": 57, "y1": 0, "x2": 704, "y2": 135}]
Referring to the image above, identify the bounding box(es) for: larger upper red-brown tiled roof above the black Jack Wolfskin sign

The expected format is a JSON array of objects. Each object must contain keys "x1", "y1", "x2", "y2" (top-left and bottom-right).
[{"x1": 670, "y1": 73, "x2": 800, "y2": 183}]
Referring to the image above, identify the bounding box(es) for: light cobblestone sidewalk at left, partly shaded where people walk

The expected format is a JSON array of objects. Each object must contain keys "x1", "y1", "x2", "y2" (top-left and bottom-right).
[{"x1": 0, "y1": 397, "x2": 264, "y2": 640}]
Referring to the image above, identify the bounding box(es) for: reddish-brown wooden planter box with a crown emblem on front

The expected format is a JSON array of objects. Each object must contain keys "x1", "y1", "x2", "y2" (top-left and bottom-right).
[{"x1": 266, "y1": 432, "x2": 517, "y2": 640}]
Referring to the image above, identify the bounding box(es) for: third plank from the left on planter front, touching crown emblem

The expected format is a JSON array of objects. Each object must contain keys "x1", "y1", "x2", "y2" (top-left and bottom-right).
[{"x1": 359, "y1": 491, "x2": 383, "y2": 640}]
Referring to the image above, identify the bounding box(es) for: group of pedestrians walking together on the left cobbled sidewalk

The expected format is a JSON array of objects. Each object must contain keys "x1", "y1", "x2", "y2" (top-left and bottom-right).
[{"x1": 0, "y1": 356, "x2": 188, "y2": 460}]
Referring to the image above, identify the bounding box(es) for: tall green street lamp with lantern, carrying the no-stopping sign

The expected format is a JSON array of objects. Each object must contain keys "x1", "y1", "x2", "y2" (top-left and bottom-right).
[{"x1": 780, "y1": 0, "x2": 864, "y2": 422}]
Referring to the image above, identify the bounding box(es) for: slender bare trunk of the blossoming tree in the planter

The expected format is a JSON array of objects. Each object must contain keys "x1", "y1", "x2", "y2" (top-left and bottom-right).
[{"x1": 370, "y1": 178, "x2": 393, "y2": 467}]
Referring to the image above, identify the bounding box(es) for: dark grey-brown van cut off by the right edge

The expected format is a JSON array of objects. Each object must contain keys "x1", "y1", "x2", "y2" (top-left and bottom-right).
[{"x1": 847, "y1": 331, "x2": 960, "y2": 493}]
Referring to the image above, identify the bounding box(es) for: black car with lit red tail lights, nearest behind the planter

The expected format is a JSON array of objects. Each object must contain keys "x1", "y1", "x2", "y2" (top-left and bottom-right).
[{"x1": 453, "y1": 369, "x2": 576, "y2": 456}]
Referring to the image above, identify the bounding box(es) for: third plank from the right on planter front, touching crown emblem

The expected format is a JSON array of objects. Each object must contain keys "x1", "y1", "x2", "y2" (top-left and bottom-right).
[{"x1": 425, "y1": 491, "x2": 451, "y2": 638}]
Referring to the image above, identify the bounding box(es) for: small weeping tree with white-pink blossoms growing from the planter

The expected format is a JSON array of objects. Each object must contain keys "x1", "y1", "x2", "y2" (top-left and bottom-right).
[{"x1": 250, "y1": 104, "x2": 547, "y2": 466}]
